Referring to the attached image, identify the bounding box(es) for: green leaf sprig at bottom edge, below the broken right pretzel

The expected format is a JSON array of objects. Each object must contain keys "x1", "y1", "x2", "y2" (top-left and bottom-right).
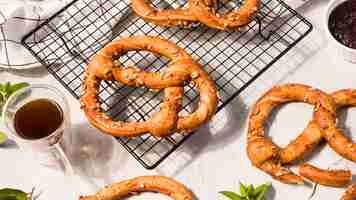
[{"x1": 219, "y1": 183, "x2": 271, "y2": 200}]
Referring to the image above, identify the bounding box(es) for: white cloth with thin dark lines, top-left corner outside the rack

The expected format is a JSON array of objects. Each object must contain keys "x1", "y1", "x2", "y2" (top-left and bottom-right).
[{"x1": 0, "y1": 0, "x2": 68, "y2": 69}]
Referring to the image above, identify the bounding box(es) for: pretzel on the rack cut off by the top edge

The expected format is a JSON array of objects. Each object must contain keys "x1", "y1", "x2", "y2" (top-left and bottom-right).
[{"x1": 131, "y1": 0, "x2": 260, "y2": 30}]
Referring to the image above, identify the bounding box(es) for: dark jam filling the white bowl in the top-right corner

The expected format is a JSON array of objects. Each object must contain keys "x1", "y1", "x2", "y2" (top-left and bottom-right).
[{"x1": 329, "y1": 0, "x2": 356, "y2": 49}]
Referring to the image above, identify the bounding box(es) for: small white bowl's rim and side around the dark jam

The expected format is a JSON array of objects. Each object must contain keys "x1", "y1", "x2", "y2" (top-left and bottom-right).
[{"x1": 324, "y1": 0, "x2": 356, "y2": 63}]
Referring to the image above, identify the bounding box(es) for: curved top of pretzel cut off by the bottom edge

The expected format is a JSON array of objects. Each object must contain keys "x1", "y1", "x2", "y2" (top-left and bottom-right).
[{"x1": 79, "y1": 176, "x2": 193, "y2": 200}]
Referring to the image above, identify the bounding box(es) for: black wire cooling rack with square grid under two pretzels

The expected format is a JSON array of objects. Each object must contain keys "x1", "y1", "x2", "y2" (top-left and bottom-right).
[{"x1": 22, "y1": 0, "x2": 312, "y2": 169}]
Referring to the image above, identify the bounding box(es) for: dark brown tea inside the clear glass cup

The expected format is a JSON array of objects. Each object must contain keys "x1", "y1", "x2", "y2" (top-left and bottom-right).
[{"x1": 14, "y1": 99, "x2": 63, "y2": 140}]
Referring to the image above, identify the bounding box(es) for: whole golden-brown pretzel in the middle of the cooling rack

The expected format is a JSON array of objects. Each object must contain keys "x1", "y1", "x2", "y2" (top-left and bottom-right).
[{"x1": 81, "y1": 36, "x2": 218, "y2": 137}]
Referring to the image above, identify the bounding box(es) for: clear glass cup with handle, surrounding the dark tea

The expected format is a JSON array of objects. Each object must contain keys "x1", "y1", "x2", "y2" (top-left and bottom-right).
[{"x1": 2, "y1": 84, "x2": 73, "y2": 175}]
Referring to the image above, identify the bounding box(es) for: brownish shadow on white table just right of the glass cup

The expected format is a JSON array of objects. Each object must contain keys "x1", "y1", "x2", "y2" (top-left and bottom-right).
[{"x1": 70, "y1": 124, "x2": 127, "y2": 189}]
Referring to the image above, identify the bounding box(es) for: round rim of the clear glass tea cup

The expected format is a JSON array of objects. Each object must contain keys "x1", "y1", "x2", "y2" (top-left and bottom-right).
[{"x1": 1, "y1": 84, "x2": 69, "y2": 143}]
